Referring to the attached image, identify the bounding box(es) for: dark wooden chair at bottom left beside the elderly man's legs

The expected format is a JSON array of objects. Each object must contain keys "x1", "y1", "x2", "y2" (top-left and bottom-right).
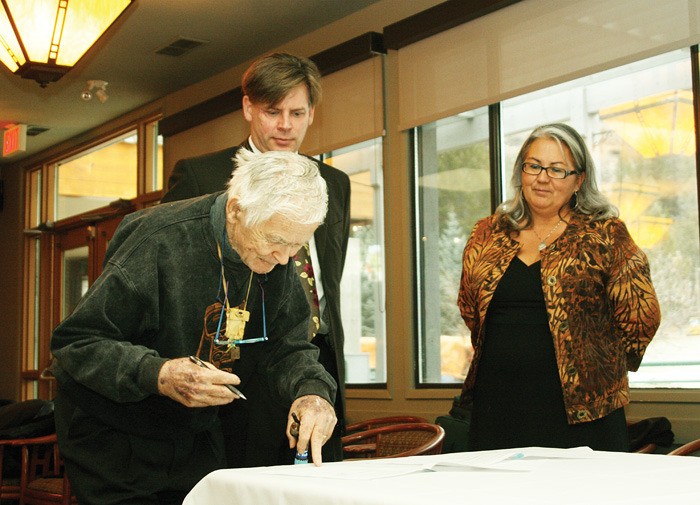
[{"x1": 0, "y1": 433, "x2": 77, "y2": 505}]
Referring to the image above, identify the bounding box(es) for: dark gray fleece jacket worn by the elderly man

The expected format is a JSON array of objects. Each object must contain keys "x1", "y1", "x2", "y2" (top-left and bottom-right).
[{"x1": 51, "y1": 193, "x2": 336, "y2": 438}]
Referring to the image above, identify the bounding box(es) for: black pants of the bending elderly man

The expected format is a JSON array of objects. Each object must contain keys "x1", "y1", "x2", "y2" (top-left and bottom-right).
[{"x1": 55, "y1": 394, "x2": 225, "y2": 505}]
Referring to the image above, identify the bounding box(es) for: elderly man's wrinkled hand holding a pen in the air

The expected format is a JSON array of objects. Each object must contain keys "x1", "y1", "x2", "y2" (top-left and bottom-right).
[{"x1": 158, "y1": 358, "x2": 241, "y2": 407}]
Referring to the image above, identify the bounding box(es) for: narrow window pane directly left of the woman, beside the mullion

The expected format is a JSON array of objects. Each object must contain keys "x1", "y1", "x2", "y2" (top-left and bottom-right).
[{"x1": 415, "y1": 107, "x2": 491, "y2": 384}]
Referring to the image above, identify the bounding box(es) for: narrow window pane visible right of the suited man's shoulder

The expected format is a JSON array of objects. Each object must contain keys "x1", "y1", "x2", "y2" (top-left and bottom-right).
[{"x1": 322, "y1": 139, "x2": 386, "y2": 385}]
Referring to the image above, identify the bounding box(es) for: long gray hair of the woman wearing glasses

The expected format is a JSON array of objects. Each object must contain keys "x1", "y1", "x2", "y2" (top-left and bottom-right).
[{"x1": 496, "y1": 123, "x2": 619, "y2": 231}]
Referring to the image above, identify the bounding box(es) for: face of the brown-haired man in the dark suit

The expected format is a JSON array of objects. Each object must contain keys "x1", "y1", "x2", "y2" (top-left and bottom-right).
[{"x1": 243, "y1": 83, "x2": 314, "y2": 152}]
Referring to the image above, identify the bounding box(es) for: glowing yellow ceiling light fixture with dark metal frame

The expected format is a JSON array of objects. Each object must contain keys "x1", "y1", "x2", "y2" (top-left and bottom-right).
[{"x1": 0, "y1": 0, "x2": 135, "y2": 88}]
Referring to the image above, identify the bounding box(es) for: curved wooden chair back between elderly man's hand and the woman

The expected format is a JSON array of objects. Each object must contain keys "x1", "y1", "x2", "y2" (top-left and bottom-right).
[{"x1": 341, "y1": 423, "x2": 445, "y2": 459}]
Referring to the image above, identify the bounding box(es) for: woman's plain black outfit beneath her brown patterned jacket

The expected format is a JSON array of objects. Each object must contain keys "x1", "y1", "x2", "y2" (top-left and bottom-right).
[{"x1": 469, "y1": 257, "x2": 628, "y2": 451}]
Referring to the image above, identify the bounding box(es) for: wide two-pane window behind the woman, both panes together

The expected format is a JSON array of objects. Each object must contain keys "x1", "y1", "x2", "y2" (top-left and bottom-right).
[{"x1": 416, "y1": 50, "x2": 700, "y2": 388}]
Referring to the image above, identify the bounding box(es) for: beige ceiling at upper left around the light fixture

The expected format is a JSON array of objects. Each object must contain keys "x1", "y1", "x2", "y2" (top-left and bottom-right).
[{"x1": 0, "y1": 0, "x2": 377, "y2": 167}]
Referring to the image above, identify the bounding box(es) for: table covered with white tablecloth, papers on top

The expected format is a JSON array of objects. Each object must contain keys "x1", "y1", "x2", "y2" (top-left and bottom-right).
[{"x1": 183, "y1": 447, "x2": 700, "y2": 505}]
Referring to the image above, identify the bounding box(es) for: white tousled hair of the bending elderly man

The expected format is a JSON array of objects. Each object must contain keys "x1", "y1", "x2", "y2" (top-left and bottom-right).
[{"x1": 228, "y1": 148, "x2": 328, "y2": 227}]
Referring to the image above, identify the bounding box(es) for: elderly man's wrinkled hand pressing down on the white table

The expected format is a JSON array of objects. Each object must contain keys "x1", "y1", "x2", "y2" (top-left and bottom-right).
[{"x1": 287, "y1": 395, "x2": 338, "y2": 466}]
